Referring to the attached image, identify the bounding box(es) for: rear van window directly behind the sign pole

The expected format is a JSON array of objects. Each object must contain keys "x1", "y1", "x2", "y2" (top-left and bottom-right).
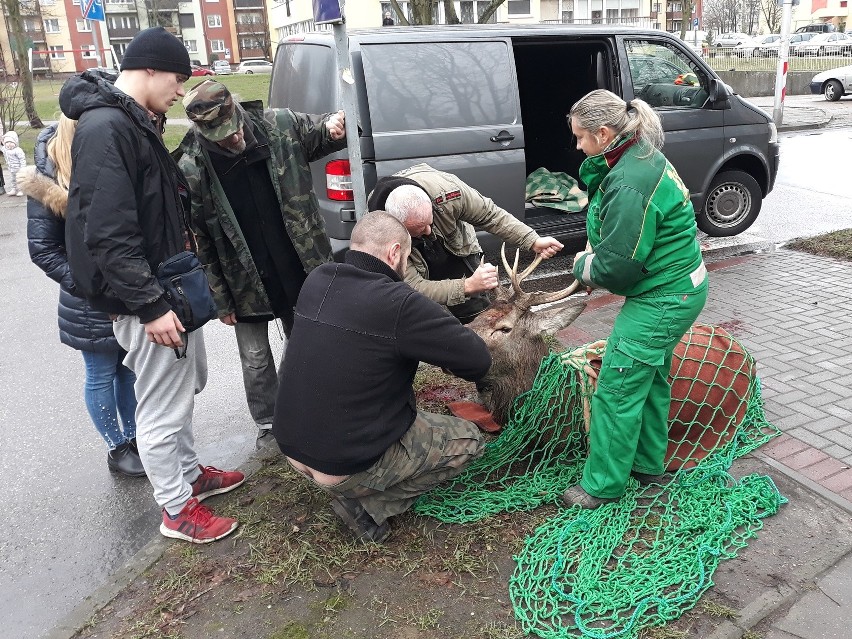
[{"x1": 269, "y1": 42, "x2": 337, "y2": 113}]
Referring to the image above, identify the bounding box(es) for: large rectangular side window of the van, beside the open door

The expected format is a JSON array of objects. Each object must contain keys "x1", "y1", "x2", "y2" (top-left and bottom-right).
[{"x1": 361, "y1": 42, "x2": 518, "y2": 132}]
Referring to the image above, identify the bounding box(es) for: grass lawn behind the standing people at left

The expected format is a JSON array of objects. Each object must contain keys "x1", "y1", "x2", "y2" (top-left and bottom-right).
[{"x1": 4, "y1": 74, "x2": 271, "y2": 162}]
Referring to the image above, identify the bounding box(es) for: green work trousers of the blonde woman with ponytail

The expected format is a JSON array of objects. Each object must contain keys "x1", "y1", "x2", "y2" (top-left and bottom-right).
[{"x1": 580, "y1": 277, "x2": 707, "y2": 498}]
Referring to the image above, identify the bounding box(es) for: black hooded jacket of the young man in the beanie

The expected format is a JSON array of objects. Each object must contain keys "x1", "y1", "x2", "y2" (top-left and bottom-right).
[{"x1": 59, "y1": 71, "x2": 189, "y2": 322}]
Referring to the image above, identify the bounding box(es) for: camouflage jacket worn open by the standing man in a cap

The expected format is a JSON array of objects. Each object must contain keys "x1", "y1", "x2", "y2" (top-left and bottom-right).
[{"x1": 175, "y1": 101, "x2": 346, "y2": 318}]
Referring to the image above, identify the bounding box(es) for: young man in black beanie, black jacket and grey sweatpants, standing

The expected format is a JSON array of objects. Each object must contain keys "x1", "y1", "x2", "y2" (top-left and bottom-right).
[{"x1": 59, "y1": 27, "x2": 245, "y2": 543}]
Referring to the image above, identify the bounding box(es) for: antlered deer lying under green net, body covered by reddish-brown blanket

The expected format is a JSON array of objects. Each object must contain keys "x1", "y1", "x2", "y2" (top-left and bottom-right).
[{"x1": 468, "y1": 244, "x2": 756, "y2": 470}]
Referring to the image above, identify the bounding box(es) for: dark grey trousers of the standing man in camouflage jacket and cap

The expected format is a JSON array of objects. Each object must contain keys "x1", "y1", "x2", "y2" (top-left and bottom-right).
[{"x1": 234, "y1": 322, "x2": 287, "y2": 428}]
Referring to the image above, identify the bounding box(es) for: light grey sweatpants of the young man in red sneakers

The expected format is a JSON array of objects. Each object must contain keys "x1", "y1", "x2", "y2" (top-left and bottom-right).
[{"x1": 113, "y1": 315, "x2": 207, "y2": 516}]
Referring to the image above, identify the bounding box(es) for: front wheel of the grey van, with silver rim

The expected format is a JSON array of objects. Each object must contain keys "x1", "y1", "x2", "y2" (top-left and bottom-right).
[{"x1": 696, "y1": 171, "x2": 763, "y2": 237}]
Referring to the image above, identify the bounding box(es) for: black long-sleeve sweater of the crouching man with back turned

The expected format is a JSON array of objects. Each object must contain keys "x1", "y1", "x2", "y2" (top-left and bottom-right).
[{"x1": 273, "y1": 251, "x2": 491, "y2": 475}]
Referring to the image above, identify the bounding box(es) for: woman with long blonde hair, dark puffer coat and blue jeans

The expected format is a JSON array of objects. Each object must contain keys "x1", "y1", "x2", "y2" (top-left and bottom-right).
[{"x1": 18, "y1": 115, "x2": 145, "y2": 477}]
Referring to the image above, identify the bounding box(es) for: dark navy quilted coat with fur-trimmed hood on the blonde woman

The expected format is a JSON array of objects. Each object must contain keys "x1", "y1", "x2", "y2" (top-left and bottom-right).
[{"x1": 18, "y1": 125, "x2": 121, "y2": 353}]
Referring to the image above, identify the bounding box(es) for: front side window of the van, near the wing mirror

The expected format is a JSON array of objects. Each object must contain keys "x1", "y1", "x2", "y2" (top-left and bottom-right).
[{"x1": 625, "y1": 40, "x2": 710, "y2": 109}]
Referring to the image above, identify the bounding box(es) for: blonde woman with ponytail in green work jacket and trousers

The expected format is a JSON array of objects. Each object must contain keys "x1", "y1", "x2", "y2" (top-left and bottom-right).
[{"x1": 562, "y1": 90, "x2": 707, "y2": 508}]
